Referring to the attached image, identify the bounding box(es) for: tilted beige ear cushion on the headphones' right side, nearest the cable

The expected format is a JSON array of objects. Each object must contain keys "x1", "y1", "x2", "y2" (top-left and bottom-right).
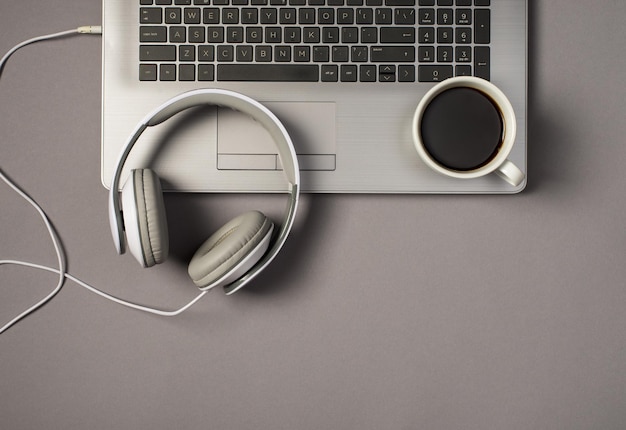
[{"x1": 188, "y1": 211, "x2": 274, "y2": 288}]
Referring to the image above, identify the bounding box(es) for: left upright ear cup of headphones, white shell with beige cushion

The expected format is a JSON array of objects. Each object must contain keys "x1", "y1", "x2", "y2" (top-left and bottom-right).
[{"x1": 122, "y1": 169, "x2": 169, "y2": 267}]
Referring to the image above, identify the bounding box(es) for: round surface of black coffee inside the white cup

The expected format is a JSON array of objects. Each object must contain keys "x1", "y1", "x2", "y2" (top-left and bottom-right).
[{"x1": 421, "y1": 87, "x2": 503, "y2": 171}]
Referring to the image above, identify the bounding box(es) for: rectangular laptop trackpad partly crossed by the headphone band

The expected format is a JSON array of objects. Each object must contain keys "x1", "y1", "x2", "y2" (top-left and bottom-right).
[{"x1": 217, "y1": 102, "x2": 336, "y2": 170}]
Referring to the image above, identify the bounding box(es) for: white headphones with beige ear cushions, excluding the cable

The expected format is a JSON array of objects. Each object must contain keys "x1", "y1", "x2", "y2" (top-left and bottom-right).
[{"x1": 109, "y1": 89, "x2": 300, "y2": 294}]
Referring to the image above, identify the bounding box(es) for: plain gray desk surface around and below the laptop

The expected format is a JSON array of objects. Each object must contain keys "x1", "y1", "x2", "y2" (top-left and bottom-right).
[{"x1": 0, "y1": 0, "x2": 626, "y2": 430}]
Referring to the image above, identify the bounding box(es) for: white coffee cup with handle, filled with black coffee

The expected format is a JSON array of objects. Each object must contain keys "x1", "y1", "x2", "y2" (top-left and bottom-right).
[{"x1": 412, "y1": 76, "x2": 525, "y2": 187}]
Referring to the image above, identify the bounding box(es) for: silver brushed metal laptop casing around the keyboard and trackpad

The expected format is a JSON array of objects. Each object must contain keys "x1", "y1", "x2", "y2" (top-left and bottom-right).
[{"x1": 101, "y1": 0, "x2": 527, "y2": 194}]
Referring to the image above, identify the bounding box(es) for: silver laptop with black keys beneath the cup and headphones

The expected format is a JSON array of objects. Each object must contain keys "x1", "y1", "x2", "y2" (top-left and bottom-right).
[{"x1": 101, "y1": 0, "x2": 528, "y2": 194}]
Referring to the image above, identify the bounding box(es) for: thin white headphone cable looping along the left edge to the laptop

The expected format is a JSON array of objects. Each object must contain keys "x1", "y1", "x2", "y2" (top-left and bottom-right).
[{"x1": 0, "y1": 26, "x2": 208, "y2": 334}]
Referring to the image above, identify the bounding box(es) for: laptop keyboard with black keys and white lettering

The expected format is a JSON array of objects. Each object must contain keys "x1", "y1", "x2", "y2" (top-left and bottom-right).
[{"x1": 136, "y1": 0, "x2": 491, "y2": 83}]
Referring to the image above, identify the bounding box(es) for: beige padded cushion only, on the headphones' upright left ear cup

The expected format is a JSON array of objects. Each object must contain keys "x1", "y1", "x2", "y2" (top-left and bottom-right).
[{"x1": 131, "y1": 169, "x2": 169, "y2": 267}]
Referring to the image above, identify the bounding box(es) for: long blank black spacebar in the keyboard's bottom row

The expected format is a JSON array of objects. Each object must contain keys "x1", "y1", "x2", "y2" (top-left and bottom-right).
[{"x1": 217, "y1": 64, "x2": 320, "y2": 82}]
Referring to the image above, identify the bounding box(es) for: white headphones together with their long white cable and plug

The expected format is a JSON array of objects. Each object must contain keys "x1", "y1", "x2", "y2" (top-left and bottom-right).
[{"x1": 0, "y1": 31, "x2": 308, "y2": 334}]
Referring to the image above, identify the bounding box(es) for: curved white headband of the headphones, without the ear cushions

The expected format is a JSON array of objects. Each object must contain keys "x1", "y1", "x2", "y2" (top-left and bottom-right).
[{"x1": 109, "y1": 89, "x2": 300, "y2": 294}]
